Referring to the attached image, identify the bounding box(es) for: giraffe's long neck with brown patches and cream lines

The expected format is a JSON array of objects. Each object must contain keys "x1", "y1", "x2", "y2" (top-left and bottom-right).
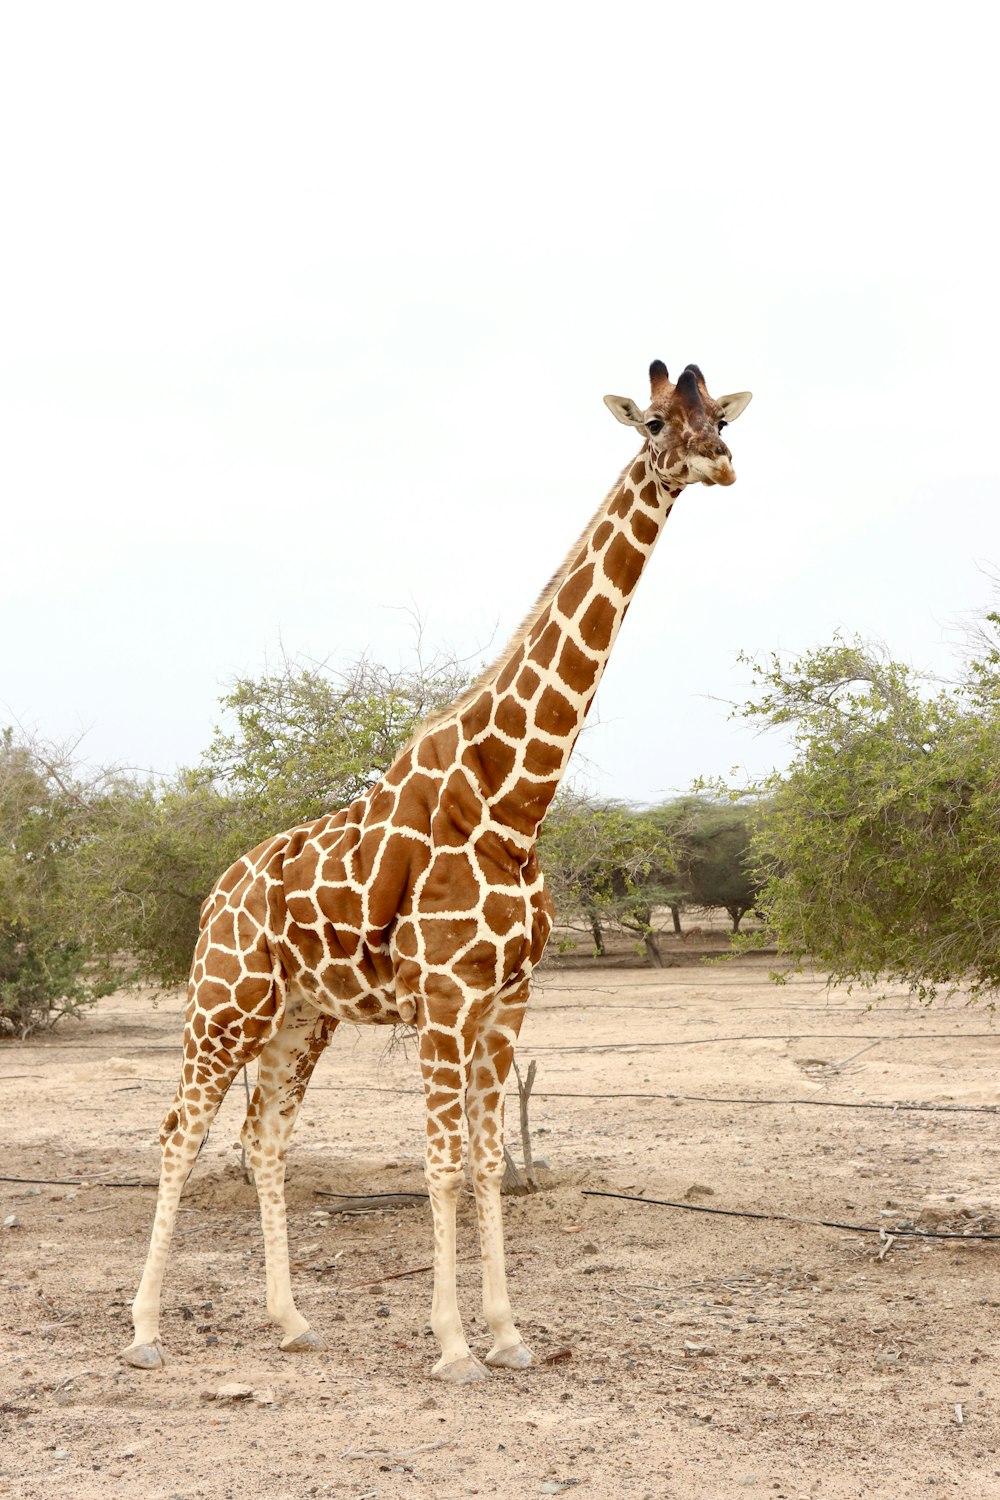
[{"x1": 457, "y1": 449, "x2": 676, "y2": 849}]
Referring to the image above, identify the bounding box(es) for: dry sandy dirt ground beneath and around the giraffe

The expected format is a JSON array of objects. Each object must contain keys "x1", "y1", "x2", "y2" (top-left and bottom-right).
[{"x1": 0, "y1": 945, "x2": 1000, "y2": 1500}]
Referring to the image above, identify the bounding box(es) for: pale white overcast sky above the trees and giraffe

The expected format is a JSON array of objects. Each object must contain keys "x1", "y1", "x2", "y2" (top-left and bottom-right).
[{"x1": 0, "y1": 0, "x2": 1000, "y2": 800}]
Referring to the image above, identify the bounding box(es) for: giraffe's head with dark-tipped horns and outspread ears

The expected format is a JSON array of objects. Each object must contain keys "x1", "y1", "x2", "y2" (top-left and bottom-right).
[{"x1": 604, "y1": 360, "x2": 750, "y2": 495}]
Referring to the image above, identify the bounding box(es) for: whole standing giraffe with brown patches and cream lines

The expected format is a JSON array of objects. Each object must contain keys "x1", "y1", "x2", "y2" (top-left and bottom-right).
[{"x1": 123, "y1": 360, "x2": 750, "y2": 1385}]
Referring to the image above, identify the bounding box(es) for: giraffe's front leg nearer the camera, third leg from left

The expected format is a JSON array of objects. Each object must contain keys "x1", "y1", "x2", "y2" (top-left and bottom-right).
[{"x1": 420, "y1": 1022, "x2": 486, "y2": 1385}]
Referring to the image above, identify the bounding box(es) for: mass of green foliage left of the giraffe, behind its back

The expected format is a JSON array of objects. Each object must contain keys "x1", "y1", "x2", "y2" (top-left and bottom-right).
[{"x1": 0, "y1": 659, "x2": 465, "y2": 1008}]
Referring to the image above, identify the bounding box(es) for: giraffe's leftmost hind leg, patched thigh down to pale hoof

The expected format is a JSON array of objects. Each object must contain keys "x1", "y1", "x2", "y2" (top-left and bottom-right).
[{"x1": 121, "y1": 935, "x2": 283, "y2": 1370}]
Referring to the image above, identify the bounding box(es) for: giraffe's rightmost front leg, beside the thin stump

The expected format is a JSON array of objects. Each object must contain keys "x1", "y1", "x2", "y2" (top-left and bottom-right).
[{"x1": 468, "y1": 983, "x2": 532, "y2": 1370}]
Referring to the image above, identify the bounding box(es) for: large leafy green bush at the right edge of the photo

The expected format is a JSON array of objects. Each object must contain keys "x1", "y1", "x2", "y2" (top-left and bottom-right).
[{"x1": 742, "y1": 617, "x2": 1000, "y2": 999}]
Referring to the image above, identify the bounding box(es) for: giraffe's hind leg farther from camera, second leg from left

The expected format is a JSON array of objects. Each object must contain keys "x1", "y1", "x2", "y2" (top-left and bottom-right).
[{"x1": 240, "y1": 1001, "x2": 337, "y2": 1355}]
